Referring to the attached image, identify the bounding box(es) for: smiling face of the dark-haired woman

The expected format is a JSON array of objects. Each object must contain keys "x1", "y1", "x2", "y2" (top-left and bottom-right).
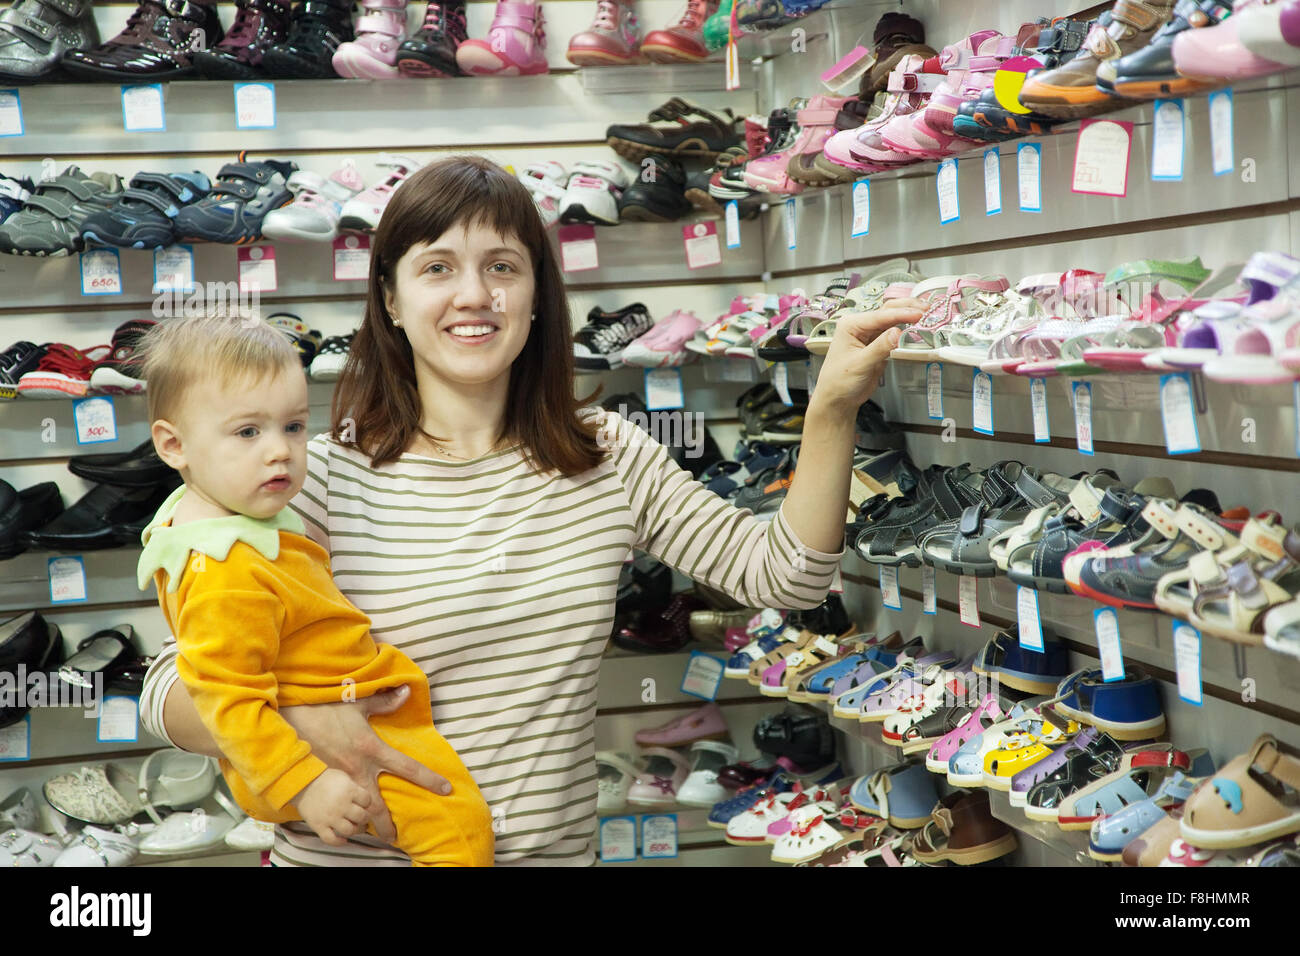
[{"x1": 385, "y1": 224, "x2": 534, "y2": 385}]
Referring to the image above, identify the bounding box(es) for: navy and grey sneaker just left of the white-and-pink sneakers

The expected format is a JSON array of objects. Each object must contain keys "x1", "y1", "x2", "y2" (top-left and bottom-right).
[{"x1": 176, "y1": 152, "x2": 298, "y2": 243}]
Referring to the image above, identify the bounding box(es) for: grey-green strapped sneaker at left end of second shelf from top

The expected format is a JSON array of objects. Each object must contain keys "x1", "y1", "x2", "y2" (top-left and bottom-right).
[{"x1": 0, "y1": 166, "x2": 124, "y2": 256}]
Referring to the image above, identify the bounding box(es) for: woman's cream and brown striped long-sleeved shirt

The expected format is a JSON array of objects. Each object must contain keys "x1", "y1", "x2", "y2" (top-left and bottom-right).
[{"x1": 140, "y1": 412, "x2": 839, "y2": 866}]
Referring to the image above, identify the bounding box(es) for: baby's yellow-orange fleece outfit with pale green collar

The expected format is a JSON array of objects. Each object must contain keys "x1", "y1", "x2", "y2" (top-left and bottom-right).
[{"x1": 138, "y1": 485, "x2": 494, "y2": 866}]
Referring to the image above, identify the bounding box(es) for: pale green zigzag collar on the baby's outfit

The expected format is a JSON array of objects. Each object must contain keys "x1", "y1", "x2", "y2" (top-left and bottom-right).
[{"x1": 135, "y1": 485, "x2": 307, "y2": 592}]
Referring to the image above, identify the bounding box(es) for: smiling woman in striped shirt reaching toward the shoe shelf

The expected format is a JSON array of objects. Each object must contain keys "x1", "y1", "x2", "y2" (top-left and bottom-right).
[{"x1": 142, "y1": 157, "x2": 920, "y2": 865}]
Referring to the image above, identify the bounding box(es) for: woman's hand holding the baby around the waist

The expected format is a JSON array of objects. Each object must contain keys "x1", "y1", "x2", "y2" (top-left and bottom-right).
[{"x1": 280, "y1": 687, "x2": 451, "y2": 843}]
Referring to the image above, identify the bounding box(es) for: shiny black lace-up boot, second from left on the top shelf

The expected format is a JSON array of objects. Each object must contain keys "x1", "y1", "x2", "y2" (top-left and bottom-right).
[{"x1": 62, "y1": 0, "x2": 225, "y2": 83}]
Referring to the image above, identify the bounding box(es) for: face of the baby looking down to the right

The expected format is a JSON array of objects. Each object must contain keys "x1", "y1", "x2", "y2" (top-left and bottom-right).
[{"x1": 177, "y1": 365, "x2": 308, "y2": 518}]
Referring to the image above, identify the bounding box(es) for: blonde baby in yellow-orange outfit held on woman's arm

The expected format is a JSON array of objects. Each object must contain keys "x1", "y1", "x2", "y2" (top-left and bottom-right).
[{"x1": 138, "y1": 317, "x2": 493, "y2": 866}]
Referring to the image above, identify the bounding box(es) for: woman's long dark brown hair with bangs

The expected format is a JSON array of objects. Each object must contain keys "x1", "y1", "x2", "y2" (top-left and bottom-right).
[{"x1": 330, "y1": 156, "x2": 606, "y2": 476}]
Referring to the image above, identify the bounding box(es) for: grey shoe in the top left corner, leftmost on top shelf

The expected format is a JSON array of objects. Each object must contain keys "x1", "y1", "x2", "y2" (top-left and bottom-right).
[{"x1": 0, "y1": 0, "x2": 99, "y2": 83}]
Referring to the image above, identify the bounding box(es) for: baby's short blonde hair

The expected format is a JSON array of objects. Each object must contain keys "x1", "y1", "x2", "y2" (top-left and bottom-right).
[{"x1": 139, "y1": 315, "x2": 302, "y2": 421}]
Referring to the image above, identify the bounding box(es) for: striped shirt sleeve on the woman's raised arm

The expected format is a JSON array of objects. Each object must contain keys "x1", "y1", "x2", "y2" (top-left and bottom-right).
[{"x1": 606, "y1": 412, "x2": 842, "y2": 609}]
